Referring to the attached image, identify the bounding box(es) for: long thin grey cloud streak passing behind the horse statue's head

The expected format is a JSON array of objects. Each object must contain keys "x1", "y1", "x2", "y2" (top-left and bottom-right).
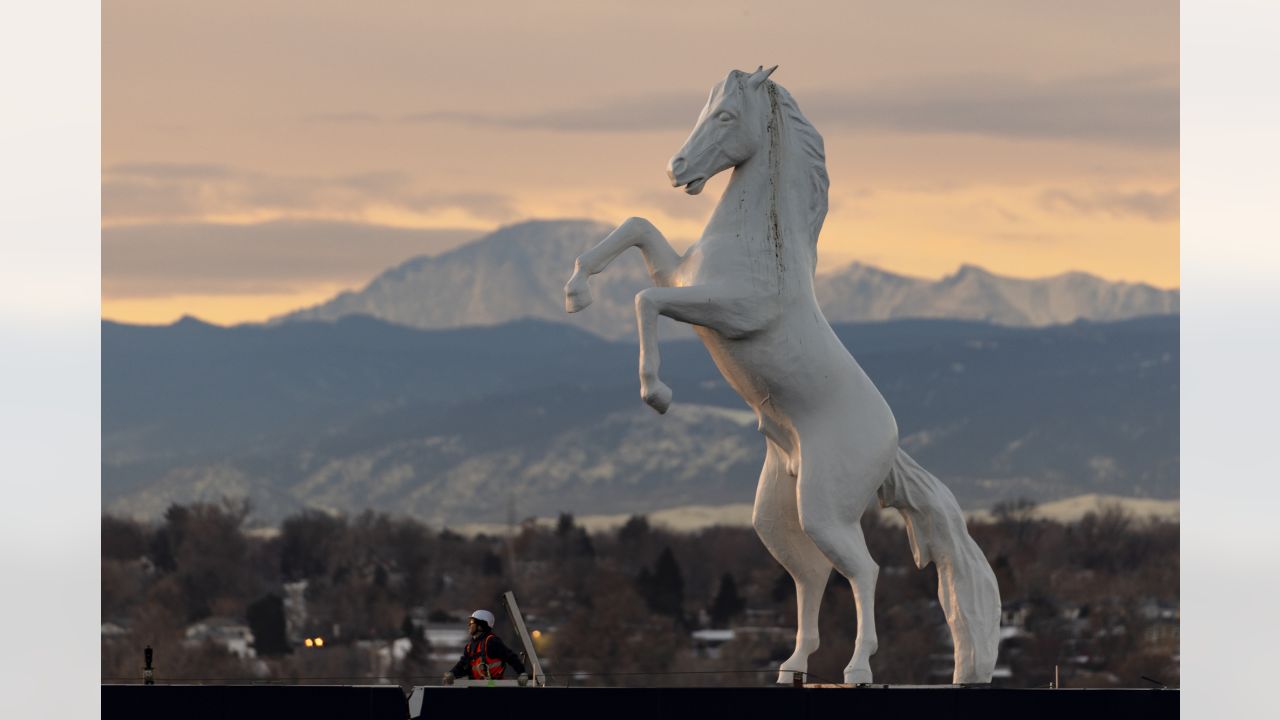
[{"x1": 403, "y1": 68, "x2": 1179, "y2": 147}]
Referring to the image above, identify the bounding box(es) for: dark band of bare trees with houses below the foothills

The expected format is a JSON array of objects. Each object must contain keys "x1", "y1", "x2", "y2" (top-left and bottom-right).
[{"x1": 102, "y1": 502, "x2": 1179, "y2": 687}]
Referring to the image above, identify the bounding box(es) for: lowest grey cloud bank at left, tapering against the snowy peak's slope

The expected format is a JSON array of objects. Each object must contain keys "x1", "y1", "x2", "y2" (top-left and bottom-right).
[{"x1": 102, "y1": 220, "x2": 481, "y2": 299}]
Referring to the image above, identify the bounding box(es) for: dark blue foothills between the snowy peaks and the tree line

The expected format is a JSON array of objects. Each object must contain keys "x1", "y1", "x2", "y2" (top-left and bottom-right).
[{"x1": 102, "y1": 315, "x2": 1179, "y2": 527}]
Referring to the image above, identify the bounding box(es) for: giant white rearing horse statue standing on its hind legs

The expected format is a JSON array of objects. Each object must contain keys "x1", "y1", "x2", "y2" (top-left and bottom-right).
[{"x1": 564, "y1": 65, "x2": 1000, "y2": 684}]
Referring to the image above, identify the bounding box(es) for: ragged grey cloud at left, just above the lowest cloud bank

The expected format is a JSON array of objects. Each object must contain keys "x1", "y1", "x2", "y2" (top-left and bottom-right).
[{"x1": 102, "y1": 164, "x2": 517, "y2": 223}]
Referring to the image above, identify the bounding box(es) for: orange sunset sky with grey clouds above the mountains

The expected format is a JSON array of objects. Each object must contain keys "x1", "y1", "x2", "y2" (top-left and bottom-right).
[{"x1": 102, "y1": 0, "x2": 1179, "y2": 324}]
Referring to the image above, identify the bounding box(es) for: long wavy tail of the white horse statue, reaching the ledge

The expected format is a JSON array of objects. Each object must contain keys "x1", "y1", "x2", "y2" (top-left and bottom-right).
[{"x1": 878, "y1": 448, "x2": 1000, "y2": 684}]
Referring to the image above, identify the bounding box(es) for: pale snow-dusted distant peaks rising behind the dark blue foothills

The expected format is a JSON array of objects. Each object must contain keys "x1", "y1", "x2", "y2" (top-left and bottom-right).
[{"x1": 274, "y1": 220, "x2": 1179, "y2": 340}]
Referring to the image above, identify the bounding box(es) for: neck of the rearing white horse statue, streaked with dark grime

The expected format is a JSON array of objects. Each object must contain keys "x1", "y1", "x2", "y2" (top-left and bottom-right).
[{"x1": 699, "y1": 83, "x2": 815, "y2": 293}]
